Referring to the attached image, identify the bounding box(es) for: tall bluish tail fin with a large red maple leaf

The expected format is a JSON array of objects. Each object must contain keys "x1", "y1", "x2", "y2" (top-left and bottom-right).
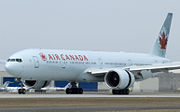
[{"x1": 151, "y1": 13, "x2": 173, "y2": 57}]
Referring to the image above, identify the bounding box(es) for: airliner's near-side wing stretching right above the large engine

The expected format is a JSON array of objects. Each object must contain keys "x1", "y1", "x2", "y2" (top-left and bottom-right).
[{"x1": 87, "y1": 62, "x2": 180, "y2": 76}]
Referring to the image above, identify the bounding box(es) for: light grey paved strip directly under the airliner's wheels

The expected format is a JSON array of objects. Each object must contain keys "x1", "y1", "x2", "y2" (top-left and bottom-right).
[{"x1": 0, "y1": 94, "x2": 180, "y2": 98}]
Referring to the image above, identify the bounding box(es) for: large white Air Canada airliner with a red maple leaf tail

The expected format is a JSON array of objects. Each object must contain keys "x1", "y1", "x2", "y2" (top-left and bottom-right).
[{"x1": 5, "y1": 13, "x2": 180, "y2": 95}]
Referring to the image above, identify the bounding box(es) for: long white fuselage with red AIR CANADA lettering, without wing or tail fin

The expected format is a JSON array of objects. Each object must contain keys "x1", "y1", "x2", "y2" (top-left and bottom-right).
[{"x1": 6, "y1": 49, "x2": 169, "y2": 81}]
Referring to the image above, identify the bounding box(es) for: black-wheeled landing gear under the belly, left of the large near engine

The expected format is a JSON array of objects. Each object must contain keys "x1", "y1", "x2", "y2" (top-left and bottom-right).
[{"x1": 66, "y1": 82, "x2": 83, "y2": 94}]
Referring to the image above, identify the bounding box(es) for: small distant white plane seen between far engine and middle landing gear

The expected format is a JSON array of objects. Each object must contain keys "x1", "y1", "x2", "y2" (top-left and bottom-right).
[{"x1": 41, "y1": 83, "x2": 71, "y2": 92}]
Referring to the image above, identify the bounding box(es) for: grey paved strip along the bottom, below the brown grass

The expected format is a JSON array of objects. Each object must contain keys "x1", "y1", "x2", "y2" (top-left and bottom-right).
[{"x1": 0, "y1": 106, "x2": 180, "y2": 112}]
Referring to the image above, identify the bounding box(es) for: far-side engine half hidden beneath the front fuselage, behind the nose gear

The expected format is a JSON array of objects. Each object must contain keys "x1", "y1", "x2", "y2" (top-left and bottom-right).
[{"x1": 23, "y1": 80, "x2": 51, "y2": 90}]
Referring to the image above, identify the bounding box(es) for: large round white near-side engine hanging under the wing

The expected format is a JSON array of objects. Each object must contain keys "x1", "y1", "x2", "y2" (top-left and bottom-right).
[{"x1": 104, "y1": 69, "x2": 135, "y2": 89}]
